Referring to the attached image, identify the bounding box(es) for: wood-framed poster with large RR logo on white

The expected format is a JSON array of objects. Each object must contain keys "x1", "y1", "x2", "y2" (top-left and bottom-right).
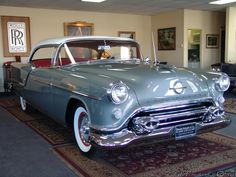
[{"x1": 1, "y1": 16, "x2": 31, "y2": 57}]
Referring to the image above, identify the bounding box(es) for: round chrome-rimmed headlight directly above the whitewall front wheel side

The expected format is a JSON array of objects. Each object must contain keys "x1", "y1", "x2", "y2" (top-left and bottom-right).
[{"x1": 110, "y1": 82, "x2": 128, "y2": 104}]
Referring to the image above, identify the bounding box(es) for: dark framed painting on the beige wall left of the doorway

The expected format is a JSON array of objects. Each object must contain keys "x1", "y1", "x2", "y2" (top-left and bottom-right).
[{"x1": 157, "y1": 27, "x2": 176, "y2": 50}]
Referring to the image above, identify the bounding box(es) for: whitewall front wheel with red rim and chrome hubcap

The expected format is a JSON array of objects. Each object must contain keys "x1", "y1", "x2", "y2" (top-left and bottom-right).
[{"x1": 74, "y1": 107, "x2": 92, "y2": 153}]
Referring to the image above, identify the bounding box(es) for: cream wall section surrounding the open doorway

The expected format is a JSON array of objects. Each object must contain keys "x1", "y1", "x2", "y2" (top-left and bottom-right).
[{"x1": 183, "y1": 10, "x2": 225, "y2": 69}]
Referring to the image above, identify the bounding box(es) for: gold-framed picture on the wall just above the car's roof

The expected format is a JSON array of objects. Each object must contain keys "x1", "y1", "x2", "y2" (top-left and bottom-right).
[{"x1": 64, "y1": 21, "x2": 94, "y2": 36}]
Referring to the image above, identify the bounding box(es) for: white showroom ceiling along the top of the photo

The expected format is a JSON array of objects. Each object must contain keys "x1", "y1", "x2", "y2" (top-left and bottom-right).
[{"x1": 0, "y1": 0, "x2": 236, "y2": 15}]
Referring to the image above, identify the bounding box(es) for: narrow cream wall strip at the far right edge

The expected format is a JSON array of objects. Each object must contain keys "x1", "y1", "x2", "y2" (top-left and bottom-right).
[{"x1": 225, "y1": 7, "x2": 236, "y2": 63}]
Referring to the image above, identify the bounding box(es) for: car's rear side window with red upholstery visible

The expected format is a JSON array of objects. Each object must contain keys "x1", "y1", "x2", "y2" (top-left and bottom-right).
[{"x1": 31, "y1": 47, "x2": 56, "y2": 68}]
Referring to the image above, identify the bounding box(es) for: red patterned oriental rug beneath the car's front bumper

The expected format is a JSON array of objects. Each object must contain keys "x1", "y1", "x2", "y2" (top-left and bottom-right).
[{"x1": 54, "y1": 133, "x2": 236, "y2": 177}]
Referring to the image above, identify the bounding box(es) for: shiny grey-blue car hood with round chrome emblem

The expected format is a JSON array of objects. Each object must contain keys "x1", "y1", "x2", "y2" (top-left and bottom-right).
[{"x1": 66, "y1": 63, "x2": 208, "y2": 106}]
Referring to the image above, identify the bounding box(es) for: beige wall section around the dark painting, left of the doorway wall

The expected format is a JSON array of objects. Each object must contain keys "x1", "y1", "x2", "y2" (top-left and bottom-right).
[{"x1": 151, "y1": 10, "x2": 184, "y2": 66}]
